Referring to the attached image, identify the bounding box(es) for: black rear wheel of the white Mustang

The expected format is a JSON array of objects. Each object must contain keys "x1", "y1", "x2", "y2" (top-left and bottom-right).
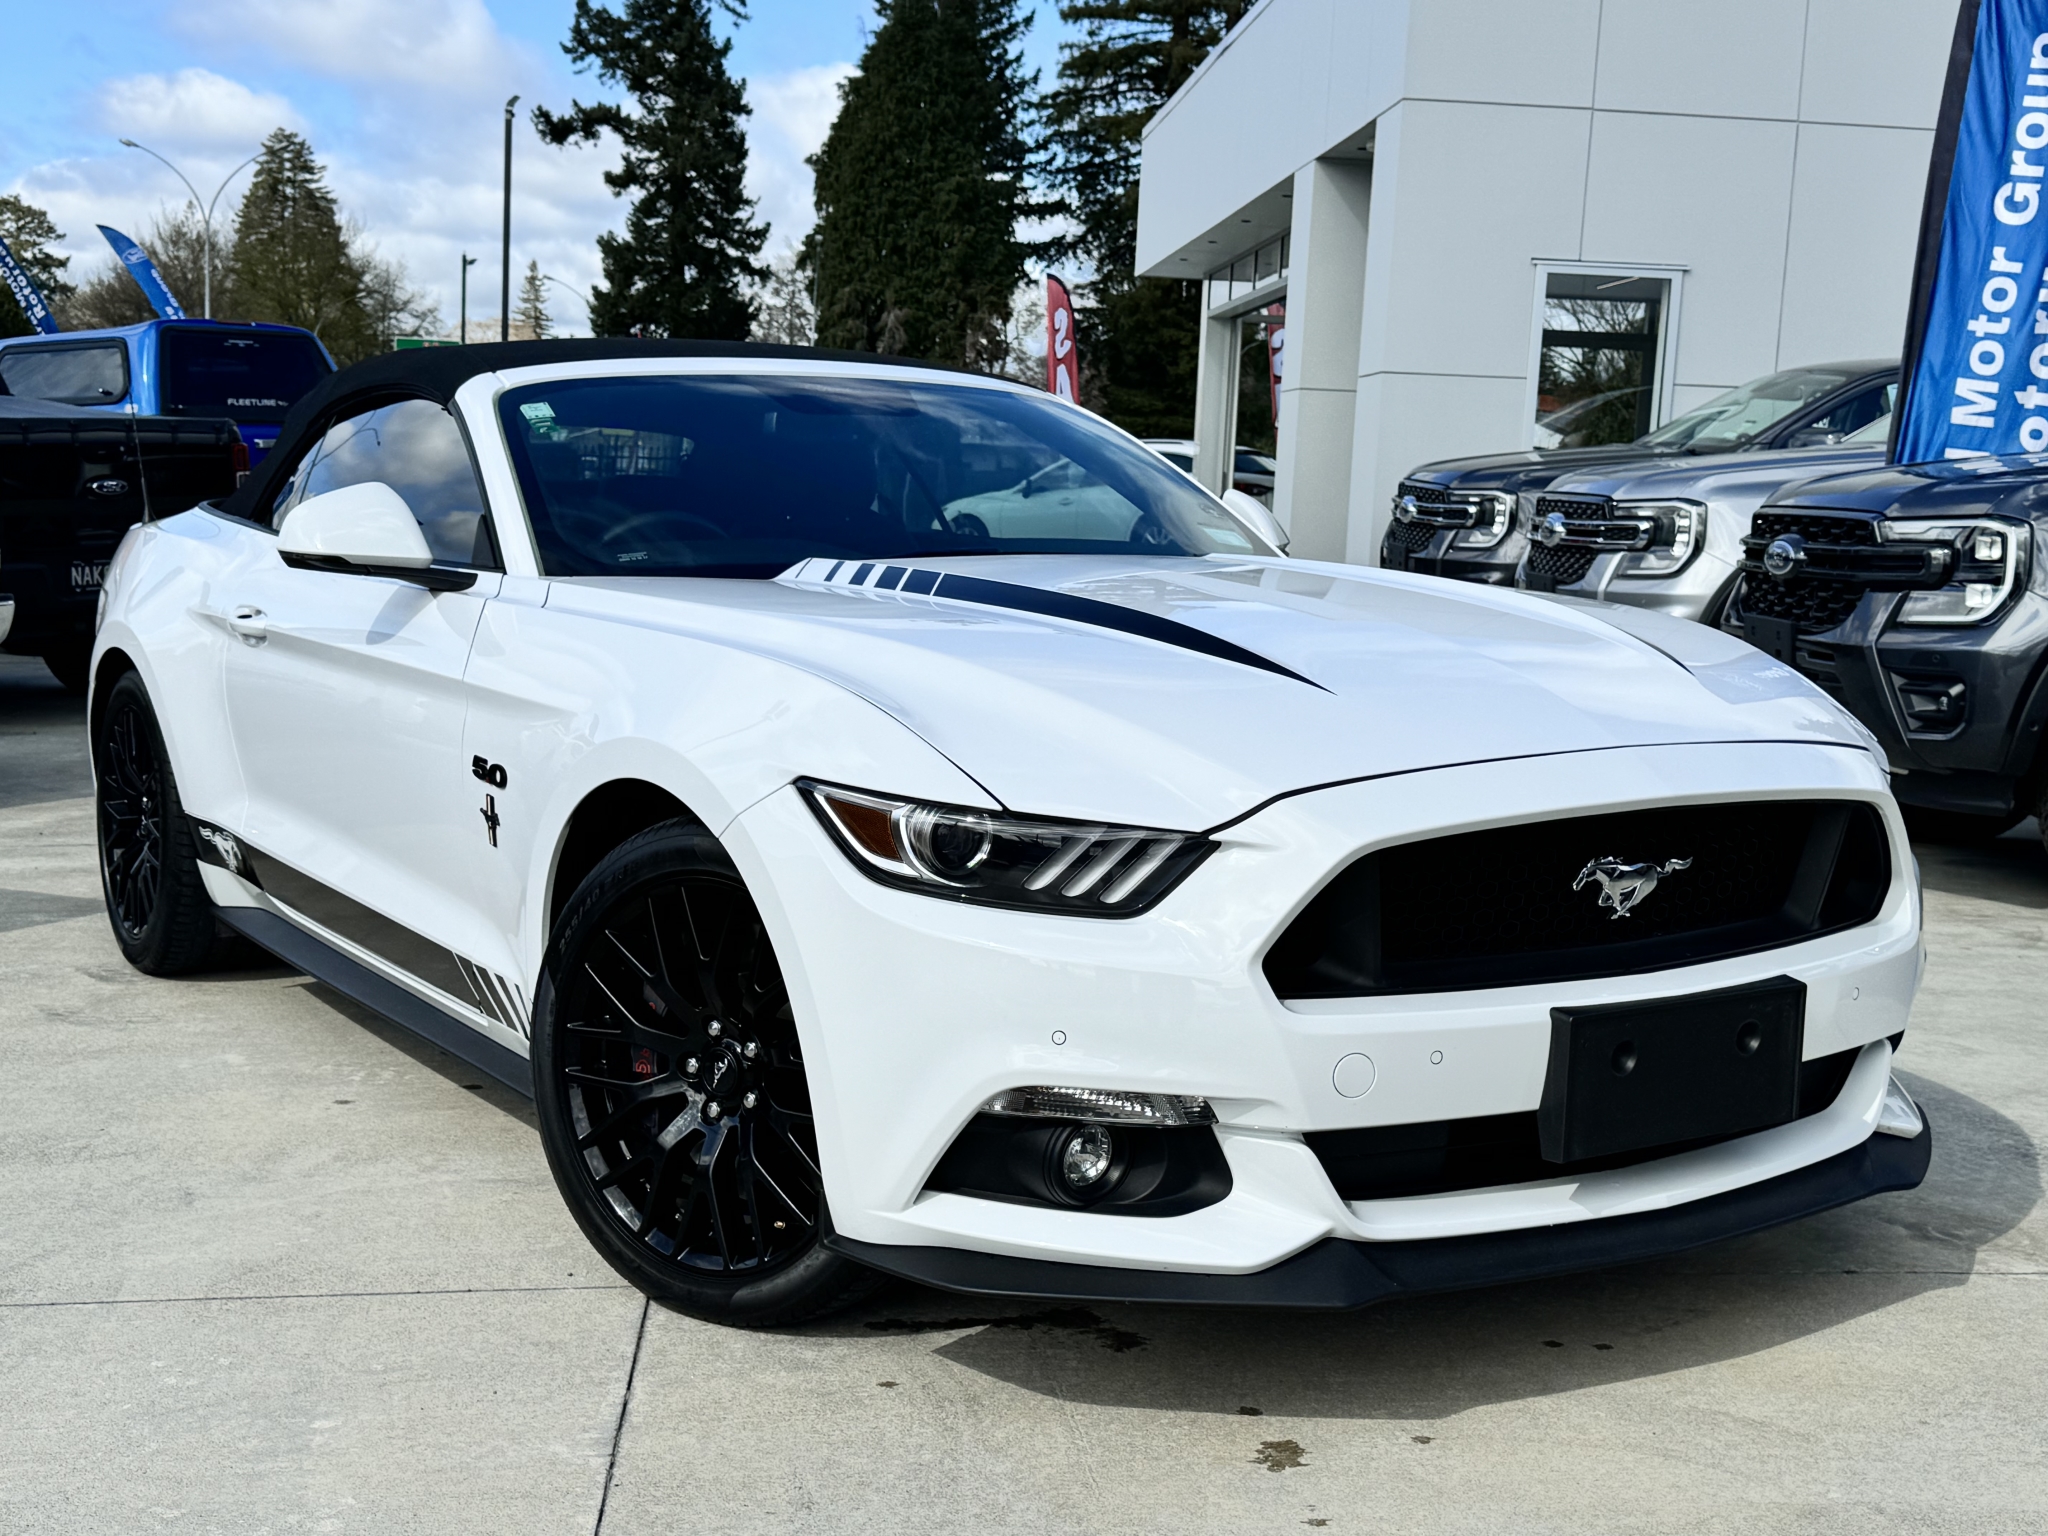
[{"x1": 92, "y1": 672, "x2": 215, "y2": 977}]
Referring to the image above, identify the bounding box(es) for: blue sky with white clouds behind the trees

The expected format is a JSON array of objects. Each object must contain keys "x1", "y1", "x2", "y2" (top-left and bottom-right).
[{"x1": 0, "y1": 0, "x2": 1061, "y2": 330}]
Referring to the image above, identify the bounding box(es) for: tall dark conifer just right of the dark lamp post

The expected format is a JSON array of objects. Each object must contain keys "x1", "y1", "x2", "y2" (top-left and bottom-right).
[{"x1": 532, "y1": 0, "x2": 768, "y2": 342}]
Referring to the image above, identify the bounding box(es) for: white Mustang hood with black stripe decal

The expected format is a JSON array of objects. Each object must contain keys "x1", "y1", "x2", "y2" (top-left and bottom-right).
[{"x1": 549, "y1": 555, "x2": 1868, "y2": 829}]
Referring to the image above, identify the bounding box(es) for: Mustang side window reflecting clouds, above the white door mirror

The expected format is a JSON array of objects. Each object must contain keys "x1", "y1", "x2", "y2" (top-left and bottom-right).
[{"x1": 272, "y1": 399, "x2": 498, "y2": 569}]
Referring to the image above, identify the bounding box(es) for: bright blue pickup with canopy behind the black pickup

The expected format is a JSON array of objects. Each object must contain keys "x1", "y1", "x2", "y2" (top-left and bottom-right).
[{"x1": 0, "y1": 319, "x2": 334, "y2": 465}]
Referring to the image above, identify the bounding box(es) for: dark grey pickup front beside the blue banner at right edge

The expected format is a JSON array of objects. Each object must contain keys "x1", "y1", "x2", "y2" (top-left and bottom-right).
[{"x1": 1722, "y1": 455, "x2": 2048, "y2": 836}]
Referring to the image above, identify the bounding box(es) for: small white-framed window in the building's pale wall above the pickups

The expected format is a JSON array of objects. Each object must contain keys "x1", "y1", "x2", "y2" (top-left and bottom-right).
[{"x1": 1530, "y1": 270, "x2": 1673, "y2": 449}]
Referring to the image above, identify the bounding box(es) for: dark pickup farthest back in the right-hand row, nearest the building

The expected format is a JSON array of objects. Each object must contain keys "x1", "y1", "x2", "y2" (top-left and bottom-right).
[{"x1": 1380, "y1": 358, "x2": 1898, "y2": 586}]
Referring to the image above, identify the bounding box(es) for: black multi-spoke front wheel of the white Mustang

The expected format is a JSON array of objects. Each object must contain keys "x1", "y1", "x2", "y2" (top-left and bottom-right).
[{"x1": 532, "y1": 821, "x2": 881, "y2": 1327}]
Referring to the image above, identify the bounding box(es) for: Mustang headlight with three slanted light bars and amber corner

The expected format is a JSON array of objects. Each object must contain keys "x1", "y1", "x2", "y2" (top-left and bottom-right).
[{"x1": 797, "y1": 778, "x2": 1214, "y2": 918}]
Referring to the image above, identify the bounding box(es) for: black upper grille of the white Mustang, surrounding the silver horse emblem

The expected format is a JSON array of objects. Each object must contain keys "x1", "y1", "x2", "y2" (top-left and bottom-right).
[{"x1": 1266, "y1": 801, "x2": 1892, "y2": 997}]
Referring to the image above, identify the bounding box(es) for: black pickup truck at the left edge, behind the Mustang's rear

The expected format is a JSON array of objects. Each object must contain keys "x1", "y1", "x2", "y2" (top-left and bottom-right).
[{"x1": 0, "y1": 395, "x2": 248, "y2": 692}]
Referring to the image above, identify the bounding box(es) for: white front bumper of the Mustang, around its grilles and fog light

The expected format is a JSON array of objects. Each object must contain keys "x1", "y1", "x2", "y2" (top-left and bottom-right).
[{"x1": 725, "y1": 743, "x2": 1921, "y2": 1294}]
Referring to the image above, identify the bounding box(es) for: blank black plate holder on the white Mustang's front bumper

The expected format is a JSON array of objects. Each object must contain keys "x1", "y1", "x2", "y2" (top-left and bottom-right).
[{"x1": 1536, "y1": 977, "x2": 1806, "y2": 1163}]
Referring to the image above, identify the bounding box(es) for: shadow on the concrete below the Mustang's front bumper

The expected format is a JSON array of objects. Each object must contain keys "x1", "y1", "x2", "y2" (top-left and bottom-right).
[{"x1": 805, "y1": 1073, "x2": 2042, "y2": 1419}]
